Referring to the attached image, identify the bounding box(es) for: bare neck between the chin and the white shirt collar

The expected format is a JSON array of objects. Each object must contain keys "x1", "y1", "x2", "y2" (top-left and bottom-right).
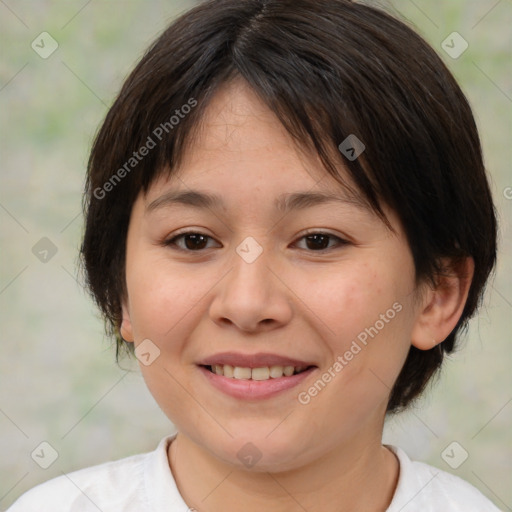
[{"x1": 168, "y1": 433, "x2": 399, "y2": 512}]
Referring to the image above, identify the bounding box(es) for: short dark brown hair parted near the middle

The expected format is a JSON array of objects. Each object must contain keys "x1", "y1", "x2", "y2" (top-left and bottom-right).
[{"x1": 81, "y1": 0, "x2": 497, "y2": 412}]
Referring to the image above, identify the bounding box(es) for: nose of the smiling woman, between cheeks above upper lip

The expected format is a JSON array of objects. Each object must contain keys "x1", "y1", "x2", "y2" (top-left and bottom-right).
[{"x1": 210, "y1": 246, "x2": 293, "y2": 332}]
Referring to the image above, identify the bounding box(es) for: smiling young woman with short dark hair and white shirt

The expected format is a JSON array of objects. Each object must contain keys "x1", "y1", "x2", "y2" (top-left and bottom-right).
[{"x1": 10, "y1": 0, "x2": 498, "y2": 512}]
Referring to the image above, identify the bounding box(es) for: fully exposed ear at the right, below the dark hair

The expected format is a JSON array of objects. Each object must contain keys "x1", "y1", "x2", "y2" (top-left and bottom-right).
[{"x1": 411, "y1": 257, "x2": 475, "y2": 350}]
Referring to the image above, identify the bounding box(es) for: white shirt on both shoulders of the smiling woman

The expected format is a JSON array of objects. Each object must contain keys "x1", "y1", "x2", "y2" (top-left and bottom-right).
[{"x1": 7, "y1": 434, "x2": 500, "y2": 512}]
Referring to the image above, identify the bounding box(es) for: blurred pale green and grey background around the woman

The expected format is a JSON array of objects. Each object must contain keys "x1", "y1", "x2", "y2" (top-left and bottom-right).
[{"x1": 0, "y1": 0, "x2": 512, "y2": 510}]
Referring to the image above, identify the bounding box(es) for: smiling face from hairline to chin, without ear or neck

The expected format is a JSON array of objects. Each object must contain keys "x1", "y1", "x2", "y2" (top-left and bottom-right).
[{"x1": 121, "y1": 79, "x2": 426, "y2": 470}]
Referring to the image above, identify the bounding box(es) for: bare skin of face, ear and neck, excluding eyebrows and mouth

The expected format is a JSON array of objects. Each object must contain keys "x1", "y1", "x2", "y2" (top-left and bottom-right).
[{"x1": 121, "y1": 81, "x2": 472, "y2": 512}]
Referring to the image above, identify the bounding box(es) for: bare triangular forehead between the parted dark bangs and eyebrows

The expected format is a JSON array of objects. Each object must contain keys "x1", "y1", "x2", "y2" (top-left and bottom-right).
[{"x1": 146, "y1": 80, "x2": 369, "y2": 210}]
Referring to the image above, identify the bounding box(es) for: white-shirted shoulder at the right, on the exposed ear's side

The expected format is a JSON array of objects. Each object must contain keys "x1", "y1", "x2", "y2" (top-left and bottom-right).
[{"x1": 387, "y1": 445, "x2": 500, "y2": 512}]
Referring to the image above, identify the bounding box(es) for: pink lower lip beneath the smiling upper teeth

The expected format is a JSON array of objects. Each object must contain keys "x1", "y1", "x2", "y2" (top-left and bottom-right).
[{"x1": 199, "y1": 366, "x2": 316, "y2": 400}]
